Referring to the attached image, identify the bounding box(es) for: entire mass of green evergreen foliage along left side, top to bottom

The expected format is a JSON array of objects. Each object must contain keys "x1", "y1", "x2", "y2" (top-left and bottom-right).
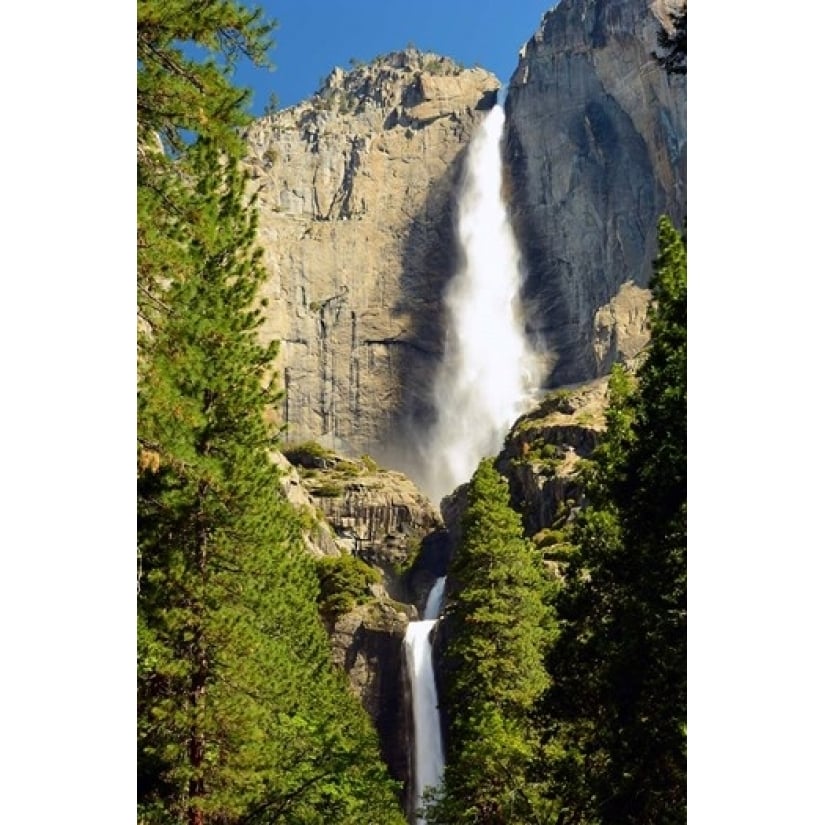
[{"x1": 137, "y1": 0, "x2": 404, "y2": 825}]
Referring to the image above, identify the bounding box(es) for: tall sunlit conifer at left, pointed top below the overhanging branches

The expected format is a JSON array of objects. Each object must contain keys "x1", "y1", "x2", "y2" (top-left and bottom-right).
[{"x1": 138, "y1": 140, "x2": 402, "y2": 825}]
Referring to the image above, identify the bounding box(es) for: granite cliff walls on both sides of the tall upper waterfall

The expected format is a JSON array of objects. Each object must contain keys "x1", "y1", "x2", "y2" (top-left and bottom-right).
[{"x1": 246, "y1": 0, "x2": 687, "y2": 471}]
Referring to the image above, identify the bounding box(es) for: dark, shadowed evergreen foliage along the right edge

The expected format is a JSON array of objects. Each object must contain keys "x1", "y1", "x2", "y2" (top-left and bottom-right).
[{"x1": 543, "y1": 218, "x2": 687, "y2": 825}]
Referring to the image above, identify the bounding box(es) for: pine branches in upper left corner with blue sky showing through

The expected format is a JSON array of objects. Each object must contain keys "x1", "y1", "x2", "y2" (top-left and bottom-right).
[{"x1": 137, "y1": 0, "x2": 276, "y2": 342}]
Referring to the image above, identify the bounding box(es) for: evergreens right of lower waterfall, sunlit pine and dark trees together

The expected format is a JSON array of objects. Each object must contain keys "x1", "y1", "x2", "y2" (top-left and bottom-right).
[{"x1": 428, "y1": 218, "x2": 687, "y2": 825}]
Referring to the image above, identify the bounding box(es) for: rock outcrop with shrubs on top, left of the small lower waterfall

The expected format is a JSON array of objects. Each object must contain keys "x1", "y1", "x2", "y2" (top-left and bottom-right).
[{"x1": 272, "y1": 442, "x2": 448, "y2": 812}]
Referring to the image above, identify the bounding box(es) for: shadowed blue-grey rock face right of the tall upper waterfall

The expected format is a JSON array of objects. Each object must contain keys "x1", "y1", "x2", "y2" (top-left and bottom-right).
[{"x1": 506, "y1": 0, "x2": 687, "y2": 386}]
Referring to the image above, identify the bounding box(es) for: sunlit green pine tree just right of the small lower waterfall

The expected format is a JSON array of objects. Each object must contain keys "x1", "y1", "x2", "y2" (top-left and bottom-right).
[{"x1": 428, "y1": 459, "x2": 551, "y2": 823}]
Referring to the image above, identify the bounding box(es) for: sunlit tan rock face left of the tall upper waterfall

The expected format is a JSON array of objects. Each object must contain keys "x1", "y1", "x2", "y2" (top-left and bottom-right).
[{"x1": 241, "y1": 50, "x2": 501, "y2": 458}]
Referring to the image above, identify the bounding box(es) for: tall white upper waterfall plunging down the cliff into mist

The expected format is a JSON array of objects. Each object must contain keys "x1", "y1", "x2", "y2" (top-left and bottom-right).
[{"x1": 421, "y1": 106, "x2": 540, "y2": 501}]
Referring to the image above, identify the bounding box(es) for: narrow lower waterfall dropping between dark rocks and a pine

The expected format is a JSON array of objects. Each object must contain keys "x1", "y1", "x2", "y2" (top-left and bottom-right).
[{"x1": 404, "y1": 577, "x2": 446, "y2": 825}]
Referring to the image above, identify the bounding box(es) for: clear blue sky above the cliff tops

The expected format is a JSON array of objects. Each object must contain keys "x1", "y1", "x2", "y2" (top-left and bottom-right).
[{"x1": 235, "y1": 0, "x2": 558, "y2": 115}]
